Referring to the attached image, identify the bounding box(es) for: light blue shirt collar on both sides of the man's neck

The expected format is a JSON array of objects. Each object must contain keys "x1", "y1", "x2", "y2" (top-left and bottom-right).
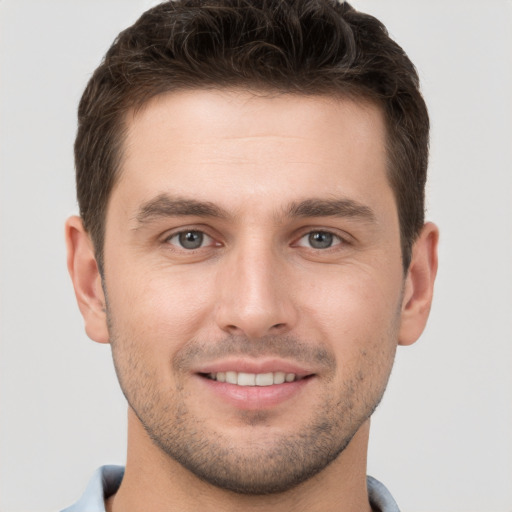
[{"x1": 62, "y1": 466, "x2": 400, "y2": 512}]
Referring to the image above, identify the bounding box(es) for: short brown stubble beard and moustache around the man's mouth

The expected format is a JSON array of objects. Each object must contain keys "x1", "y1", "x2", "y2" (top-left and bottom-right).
[{"x1": 109, "y1": 318, "x2": 394, "y2": 495}]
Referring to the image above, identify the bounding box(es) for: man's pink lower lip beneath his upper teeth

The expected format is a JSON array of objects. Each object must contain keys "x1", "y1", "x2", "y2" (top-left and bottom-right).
[{"x1": 198, "y1": 375, "x2": 313, "y2": 410}]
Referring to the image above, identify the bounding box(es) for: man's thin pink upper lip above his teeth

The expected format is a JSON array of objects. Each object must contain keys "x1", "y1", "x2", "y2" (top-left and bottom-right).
[{"x1": 194, "y1": 358, "x2": 315, "y2": 377}]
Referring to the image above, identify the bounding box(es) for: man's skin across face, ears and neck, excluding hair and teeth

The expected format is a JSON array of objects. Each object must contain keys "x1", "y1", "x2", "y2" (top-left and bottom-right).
[{"x1": 66, "y1": 90, "x2": 438, "y2": 512}]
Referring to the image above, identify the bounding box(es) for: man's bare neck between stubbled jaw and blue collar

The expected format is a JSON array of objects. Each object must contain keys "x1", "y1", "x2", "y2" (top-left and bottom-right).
[{"x1": 106, "y1": 411, "x2": 371, "y2": 512}]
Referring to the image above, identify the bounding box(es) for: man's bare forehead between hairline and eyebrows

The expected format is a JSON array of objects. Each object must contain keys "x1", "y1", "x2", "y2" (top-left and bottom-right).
[{"x1": 113, "y1": 90, "x2": 390, "y2": 220}]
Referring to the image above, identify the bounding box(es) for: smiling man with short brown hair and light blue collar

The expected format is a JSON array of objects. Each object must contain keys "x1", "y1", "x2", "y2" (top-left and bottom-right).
[{"x1": 66, "y1": 0, "x2": 438, "y2": 512}]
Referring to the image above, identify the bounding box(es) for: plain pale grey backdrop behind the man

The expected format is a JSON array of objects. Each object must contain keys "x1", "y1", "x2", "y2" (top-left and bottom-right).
[{"x1": 0, "y1": 0, "x2": 512, "y2": 512}]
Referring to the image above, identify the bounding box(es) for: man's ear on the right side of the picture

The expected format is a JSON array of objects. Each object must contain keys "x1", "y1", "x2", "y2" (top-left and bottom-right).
[{"x1": 398, "y1": 222, "x2": 439, "y2": 345}]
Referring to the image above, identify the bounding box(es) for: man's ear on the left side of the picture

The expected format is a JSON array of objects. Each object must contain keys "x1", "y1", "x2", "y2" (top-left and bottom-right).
[{"x1": 66, "y1": 216, "x2": 109, "y2": 343}]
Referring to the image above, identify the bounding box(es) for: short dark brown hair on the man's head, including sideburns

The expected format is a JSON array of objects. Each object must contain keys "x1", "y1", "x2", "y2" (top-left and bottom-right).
[{"x1": 75, "y1": 0, "x2": 429, "y2": 271}]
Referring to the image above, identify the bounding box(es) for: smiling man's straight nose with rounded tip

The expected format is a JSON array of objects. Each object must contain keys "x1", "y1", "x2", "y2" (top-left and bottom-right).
[{"x1": 216, "y1": 243, "x2": 298, "y2": 339}]
